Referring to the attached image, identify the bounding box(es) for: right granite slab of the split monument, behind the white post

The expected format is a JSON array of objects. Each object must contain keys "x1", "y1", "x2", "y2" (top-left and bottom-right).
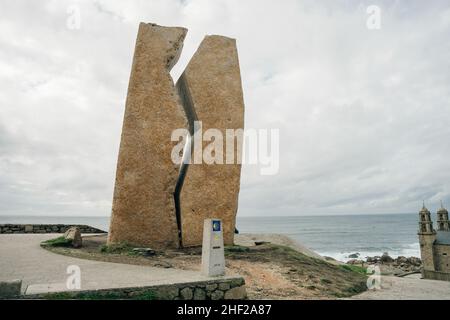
[{"x1": 177, "y1": 35, "x2": 244, "y2": 247}]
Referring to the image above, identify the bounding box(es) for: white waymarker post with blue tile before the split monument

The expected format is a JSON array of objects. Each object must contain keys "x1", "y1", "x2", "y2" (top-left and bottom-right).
[{"x1": 202, "y1": 219, "x2": 225, "y2": 277}]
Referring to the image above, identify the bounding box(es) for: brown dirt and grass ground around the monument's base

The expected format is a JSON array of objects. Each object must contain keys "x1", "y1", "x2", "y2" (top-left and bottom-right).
[{"x1": 47, "y1": 235, "x2": 367, "y2": 299}]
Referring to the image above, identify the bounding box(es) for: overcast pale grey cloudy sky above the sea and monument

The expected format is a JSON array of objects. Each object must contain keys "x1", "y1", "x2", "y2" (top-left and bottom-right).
[{"x1": 0, "y1": 0, "x2": 450, "y2": 216}]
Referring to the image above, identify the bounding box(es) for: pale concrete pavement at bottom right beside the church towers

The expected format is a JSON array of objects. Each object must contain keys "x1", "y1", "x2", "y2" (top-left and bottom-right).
[{"x1": 351, "y1": 275, "x2": 450, "y2": 300}]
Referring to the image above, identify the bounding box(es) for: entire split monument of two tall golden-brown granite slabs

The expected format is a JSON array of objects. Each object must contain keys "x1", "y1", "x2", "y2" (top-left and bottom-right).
[{"x1": 108, "y1": 23, "x2": 244, "y2": 249}]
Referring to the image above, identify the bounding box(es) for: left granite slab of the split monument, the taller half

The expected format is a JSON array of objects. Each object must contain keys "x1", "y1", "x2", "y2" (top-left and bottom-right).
[{"x1": 108, "y1": 23, "x2": 188, "y2": 249}]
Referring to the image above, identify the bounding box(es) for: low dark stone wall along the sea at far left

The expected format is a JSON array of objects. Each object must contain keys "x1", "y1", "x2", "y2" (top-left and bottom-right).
[{"x1": 0, "y1": 224, "x2": 105, "y2": 233}]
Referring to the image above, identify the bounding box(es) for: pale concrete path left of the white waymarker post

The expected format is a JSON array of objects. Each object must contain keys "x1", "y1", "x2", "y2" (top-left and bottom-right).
[{"x1": 0, "y1": 234, "x2": 230, "y2": 294}]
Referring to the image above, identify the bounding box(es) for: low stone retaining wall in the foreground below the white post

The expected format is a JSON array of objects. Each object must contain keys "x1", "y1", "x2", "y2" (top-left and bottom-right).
[{"x1": 23, "y1": 277, "x2": 247, "y2": 300}]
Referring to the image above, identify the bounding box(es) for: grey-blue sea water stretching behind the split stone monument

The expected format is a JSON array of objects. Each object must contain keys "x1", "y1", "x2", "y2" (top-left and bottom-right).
[{"x1": 0, "y1": 213, "x2": 420, "y2": 261}]
